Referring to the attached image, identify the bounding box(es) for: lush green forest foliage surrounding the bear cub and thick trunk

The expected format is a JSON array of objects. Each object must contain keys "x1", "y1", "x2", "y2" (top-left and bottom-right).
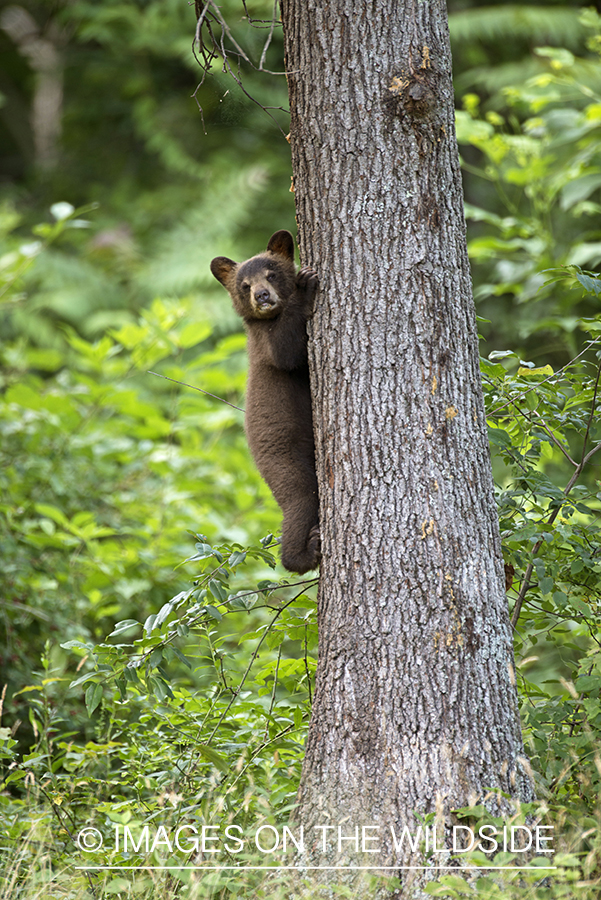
[{"x1": 0, "y1": 0, "x2": 601, "y2": 900}]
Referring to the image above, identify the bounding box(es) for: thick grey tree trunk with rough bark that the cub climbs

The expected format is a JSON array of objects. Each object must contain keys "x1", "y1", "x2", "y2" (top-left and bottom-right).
[{"x1": 282, "y1": 0, "x2": 533, "y2": 884}]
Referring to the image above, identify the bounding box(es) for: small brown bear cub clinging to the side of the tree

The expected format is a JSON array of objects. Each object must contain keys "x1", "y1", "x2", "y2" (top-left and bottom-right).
[{"x1": 211, "y1": 231, "x2": 321, "y2": 575}]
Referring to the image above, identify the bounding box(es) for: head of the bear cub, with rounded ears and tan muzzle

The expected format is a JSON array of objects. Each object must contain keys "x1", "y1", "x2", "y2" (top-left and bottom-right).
[{"x1": 211, "y1": 231, "x2": 296, "y2": 322}]
